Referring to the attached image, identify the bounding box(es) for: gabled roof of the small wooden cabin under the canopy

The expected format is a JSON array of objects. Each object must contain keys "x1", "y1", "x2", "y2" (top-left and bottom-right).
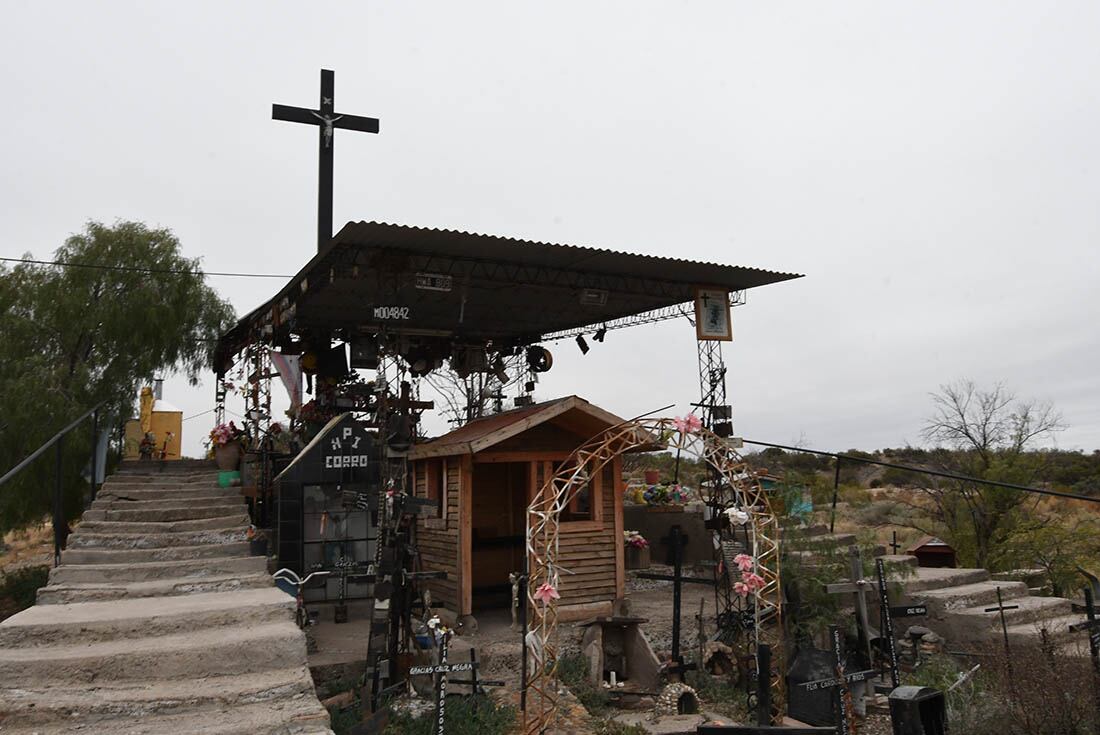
[{"x1": 409, "y1": 396, "x2": 638, "y2": 459}]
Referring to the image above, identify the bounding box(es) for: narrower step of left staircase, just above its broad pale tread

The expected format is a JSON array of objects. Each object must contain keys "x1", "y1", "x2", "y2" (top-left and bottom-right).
[{"x1": 50, "y1": 555, "x2": 267, "y2": 584}]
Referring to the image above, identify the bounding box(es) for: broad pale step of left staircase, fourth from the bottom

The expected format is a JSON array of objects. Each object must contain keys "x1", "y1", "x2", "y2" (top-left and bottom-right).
[{"x1": 0, "y1": 585, "x2": 295, "y2": 652}]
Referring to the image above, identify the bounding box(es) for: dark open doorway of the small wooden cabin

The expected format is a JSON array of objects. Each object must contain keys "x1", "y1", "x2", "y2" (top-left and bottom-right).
[{"x1": 470, "y1": 462, "x2": 531, "y2": 613}]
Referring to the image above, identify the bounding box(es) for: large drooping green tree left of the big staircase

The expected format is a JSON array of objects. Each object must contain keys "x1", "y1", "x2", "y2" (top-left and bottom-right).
[{"x1": 0, "y1": 222, "x2": 234, "y2": 531}]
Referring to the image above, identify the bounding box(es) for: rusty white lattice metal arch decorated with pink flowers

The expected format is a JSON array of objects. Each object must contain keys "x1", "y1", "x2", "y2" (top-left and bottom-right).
[{"x1": 524, "y1": 415, "x2": 782, "y2": 733}]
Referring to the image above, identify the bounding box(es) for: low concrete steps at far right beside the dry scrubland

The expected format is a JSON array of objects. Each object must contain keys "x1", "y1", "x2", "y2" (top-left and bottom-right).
[{"x1": 887, "y1": 556, "x2": 1086, "y2": 645}]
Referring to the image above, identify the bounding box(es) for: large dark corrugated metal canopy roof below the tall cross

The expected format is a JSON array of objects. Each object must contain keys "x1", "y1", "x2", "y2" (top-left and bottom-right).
[{"x1": 218, "y1": 222, "x2": 800, "y2": 364}]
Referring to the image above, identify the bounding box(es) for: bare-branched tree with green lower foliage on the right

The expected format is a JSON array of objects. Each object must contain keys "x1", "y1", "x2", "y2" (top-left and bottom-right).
[{"x1": 911, "y1": 381, "x2": 1064, "y2": 567}]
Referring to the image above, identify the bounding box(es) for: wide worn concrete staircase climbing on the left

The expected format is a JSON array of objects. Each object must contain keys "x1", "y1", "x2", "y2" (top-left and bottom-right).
[{"x1": 0, "y1": 460, "x2": 331, "y2": 735}]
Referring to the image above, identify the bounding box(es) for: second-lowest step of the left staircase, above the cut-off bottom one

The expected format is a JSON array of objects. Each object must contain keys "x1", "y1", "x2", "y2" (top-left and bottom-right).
[{"x1": 0, "y1": 668, "x2": 317, "y2": 733}]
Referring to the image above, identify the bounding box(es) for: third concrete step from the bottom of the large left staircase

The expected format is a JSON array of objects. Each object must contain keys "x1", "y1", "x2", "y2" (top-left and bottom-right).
[{"x1": 0, "y1": 624, "x2": 306, "y2": 687}]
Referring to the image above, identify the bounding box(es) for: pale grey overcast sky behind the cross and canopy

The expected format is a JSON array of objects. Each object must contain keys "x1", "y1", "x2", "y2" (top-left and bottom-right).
[{"x1": 0, "y1": 0, "x2": 1100, "y2": 453}]
